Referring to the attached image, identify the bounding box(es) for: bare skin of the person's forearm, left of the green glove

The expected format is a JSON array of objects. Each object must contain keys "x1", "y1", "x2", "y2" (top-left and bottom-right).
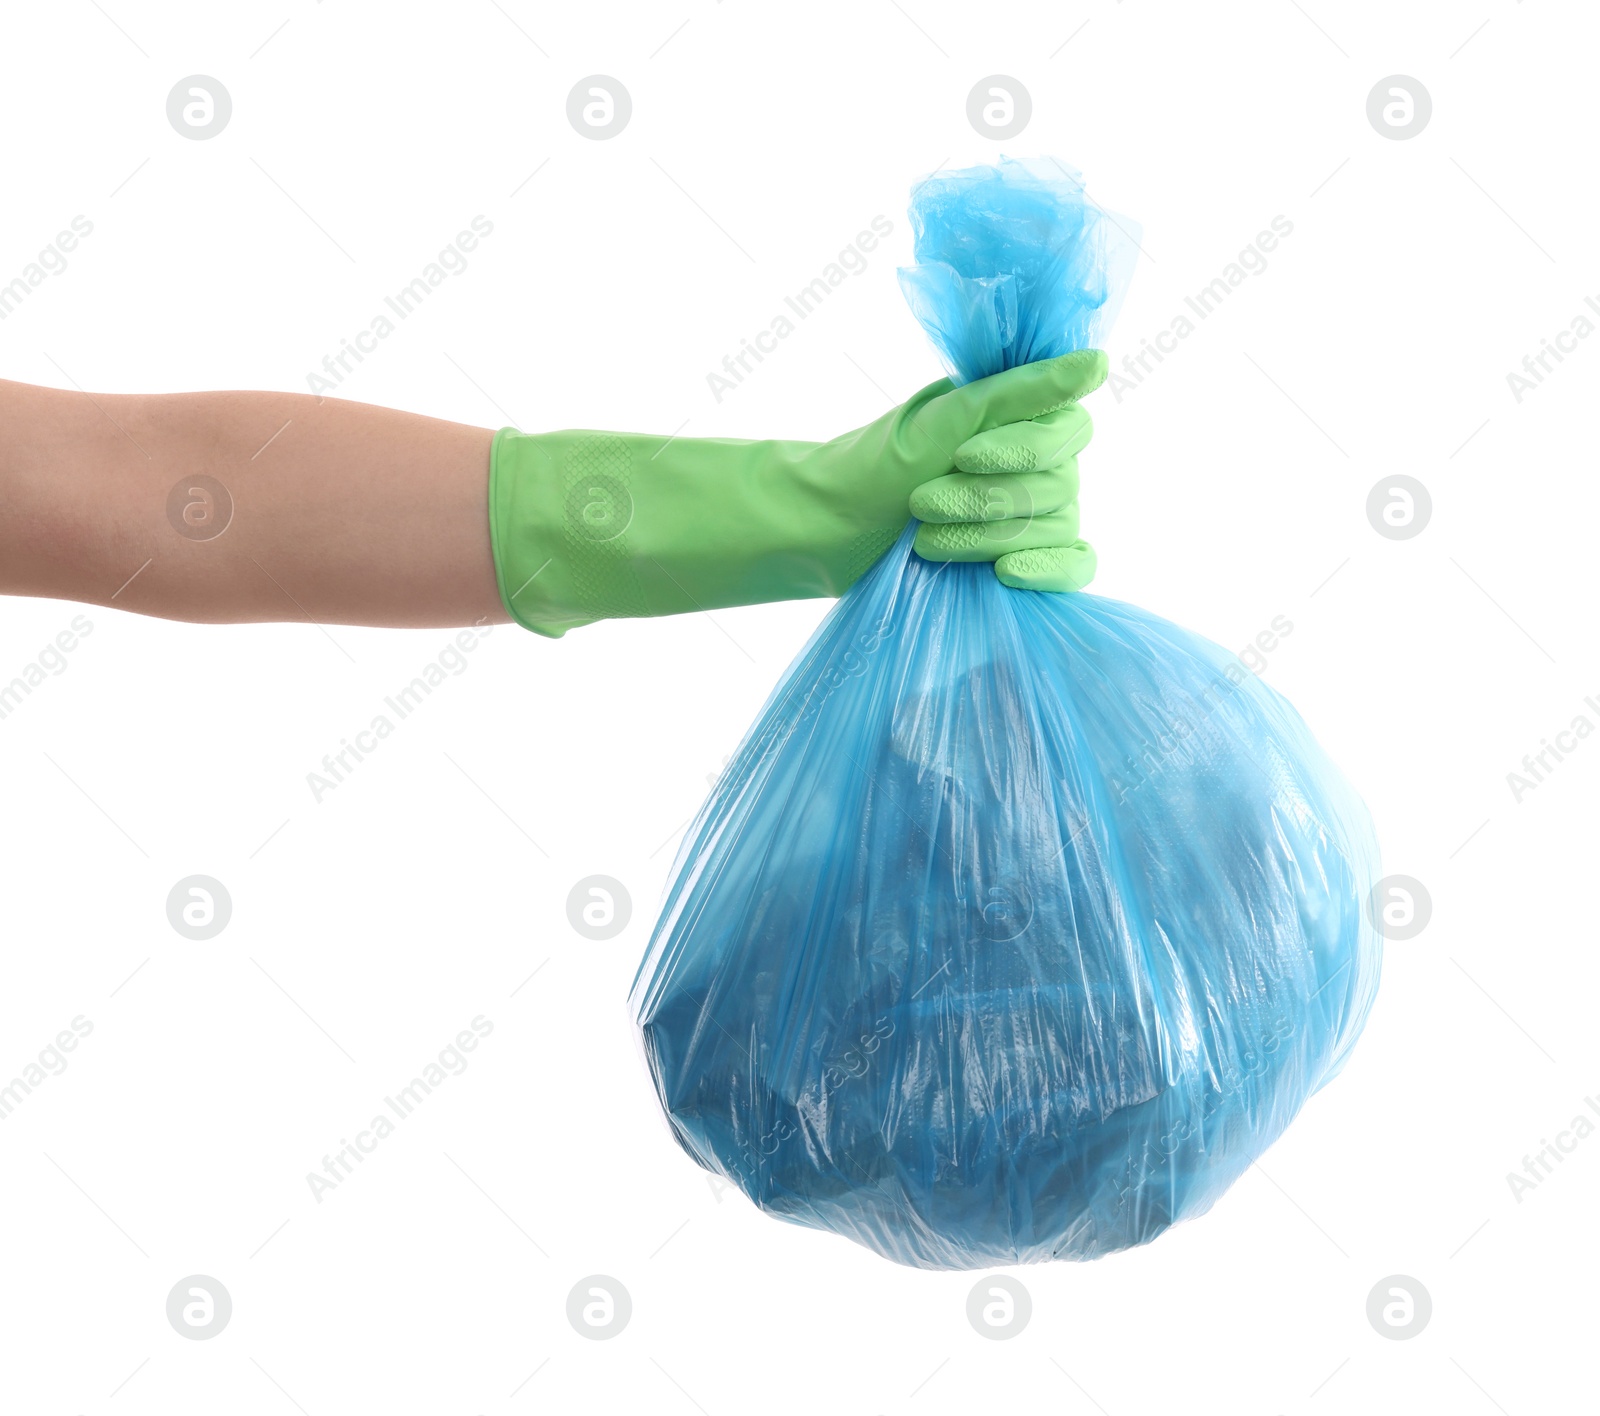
[{"x1": 0, "y1": 381, "x2": 506, "y2": 626}]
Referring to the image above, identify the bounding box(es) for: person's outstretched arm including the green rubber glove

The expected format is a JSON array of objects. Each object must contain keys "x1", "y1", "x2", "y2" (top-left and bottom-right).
[{"x1": 0, "y1": 349, "x2": 1106, "y2": 637}]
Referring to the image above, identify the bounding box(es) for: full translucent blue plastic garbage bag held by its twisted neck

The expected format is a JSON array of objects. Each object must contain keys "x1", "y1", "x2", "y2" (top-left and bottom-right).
[{"x1": 634, "y1": 163, "x2": 1379, "y2": 1269}]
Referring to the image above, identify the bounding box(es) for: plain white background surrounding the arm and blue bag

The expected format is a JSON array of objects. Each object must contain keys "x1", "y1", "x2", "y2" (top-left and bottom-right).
[{"x1": 0, "y1": 0, "x2": 1600, "y2": 1416}]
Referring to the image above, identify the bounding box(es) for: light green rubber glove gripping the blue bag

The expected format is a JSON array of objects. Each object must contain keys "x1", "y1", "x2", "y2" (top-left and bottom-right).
[{"x1": 490, "y1": 349, "x2": 1107, "y2": 637}]
